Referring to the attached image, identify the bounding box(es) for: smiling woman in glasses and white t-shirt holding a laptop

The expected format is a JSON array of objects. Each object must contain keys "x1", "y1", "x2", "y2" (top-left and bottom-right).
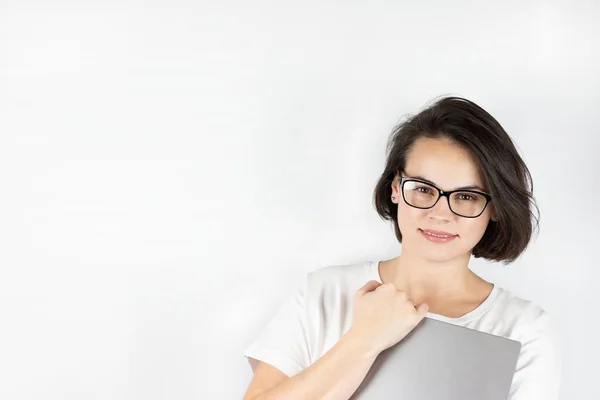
[{"x1": 244, "y1": 97, "x2": 560, "y2": 400}]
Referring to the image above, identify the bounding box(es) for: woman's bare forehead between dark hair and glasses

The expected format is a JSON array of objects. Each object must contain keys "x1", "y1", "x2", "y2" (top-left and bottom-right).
[{"x1": 404, "y1": 138, "x2": 486, "y2": 190}]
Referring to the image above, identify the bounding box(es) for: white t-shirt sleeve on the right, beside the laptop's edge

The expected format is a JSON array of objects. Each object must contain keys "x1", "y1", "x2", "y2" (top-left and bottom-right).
[{"x1": 508, "y1": 313, "x2": 562, "y2": 400}]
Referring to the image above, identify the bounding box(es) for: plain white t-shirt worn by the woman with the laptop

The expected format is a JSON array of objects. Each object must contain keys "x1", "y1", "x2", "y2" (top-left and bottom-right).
[{"x1": 244, "y1": 261, "x2": 561, "y2": 400}]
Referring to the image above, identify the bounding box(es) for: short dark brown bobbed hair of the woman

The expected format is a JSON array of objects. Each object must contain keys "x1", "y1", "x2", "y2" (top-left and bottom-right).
[{"x1": 373, "y1": 96, "x2": 539, "y2": 264}]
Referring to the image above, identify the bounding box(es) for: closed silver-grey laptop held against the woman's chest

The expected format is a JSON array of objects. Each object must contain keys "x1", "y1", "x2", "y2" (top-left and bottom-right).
[{"x1": 351, "y1": 318, "x2": 521, "y2": 400}]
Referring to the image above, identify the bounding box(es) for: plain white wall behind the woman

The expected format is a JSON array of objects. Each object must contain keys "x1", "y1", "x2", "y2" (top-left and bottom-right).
[{"x1": 0, "y1": 0, "x2": 600, "y2": 400}]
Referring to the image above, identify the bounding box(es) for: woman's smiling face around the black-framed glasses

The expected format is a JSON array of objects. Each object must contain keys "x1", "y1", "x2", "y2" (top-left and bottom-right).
[{"x1": 392, "y1": 138, "x2": 495, "y2": 262}]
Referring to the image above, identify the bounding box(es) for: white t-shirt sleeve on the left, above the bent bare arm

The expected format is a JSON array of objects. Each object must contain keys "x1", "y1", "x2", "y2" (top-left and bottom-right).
[{"x1": 244, "y1": 279, "x2": 310, "y2": 377}]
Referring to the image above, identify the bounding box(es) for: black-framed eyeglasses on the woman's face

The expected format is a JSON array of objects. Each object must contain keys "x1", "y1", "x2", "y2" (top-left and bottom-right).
[{"x1": 400, "y1": 176, "x2": 492, "y2": 218}]
